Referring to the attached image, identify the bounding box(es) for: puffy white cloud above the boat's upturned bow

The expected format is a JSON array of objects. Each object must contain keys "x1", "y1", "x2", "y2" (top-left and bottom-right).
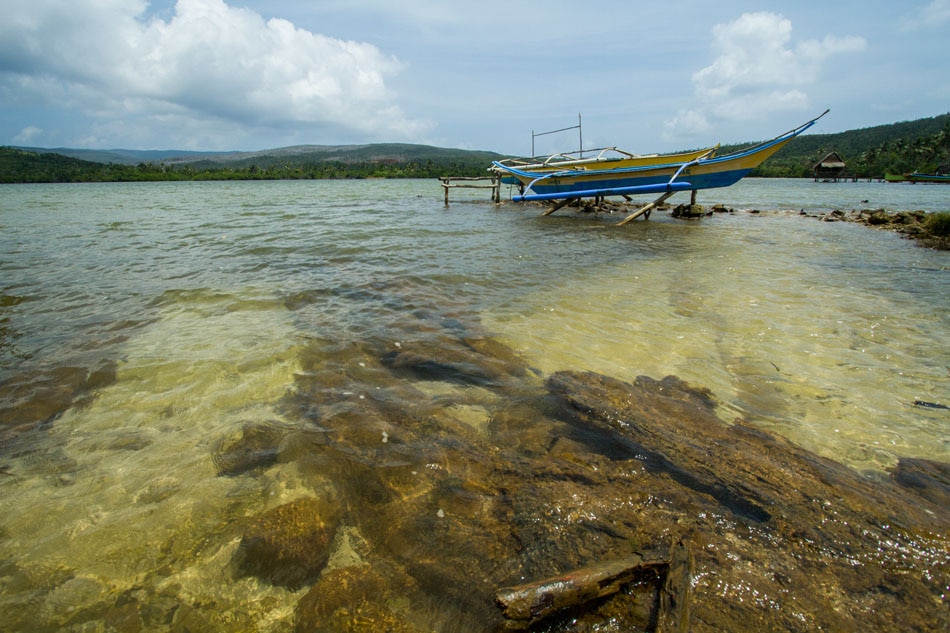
[{"x1": 666, "y1": 12, "x2": 867, "y2": 137}]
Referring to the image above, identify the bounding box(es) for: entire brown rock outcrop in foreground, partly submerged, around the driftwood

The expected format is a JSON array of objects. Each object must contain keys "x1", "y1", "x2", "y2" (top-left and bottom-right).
[{"x1": 278, "y1": 296, "x2": 950, "y2": 633}]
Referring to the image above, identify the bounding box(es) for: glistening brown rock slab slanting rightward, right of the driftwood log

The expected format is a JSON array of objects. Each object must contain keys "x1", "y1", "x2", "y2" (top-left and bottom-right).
[{"x1": 544, "y1": 372, "x2": 950, "y2": 631}]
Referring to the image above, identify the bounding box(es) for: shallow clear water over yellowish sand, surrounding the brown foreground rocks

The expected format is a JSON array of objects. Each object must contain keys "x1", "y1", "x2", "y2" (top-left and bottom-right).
[{"x1": 0, "y1": 180, "x2": 950, "y2": 630}]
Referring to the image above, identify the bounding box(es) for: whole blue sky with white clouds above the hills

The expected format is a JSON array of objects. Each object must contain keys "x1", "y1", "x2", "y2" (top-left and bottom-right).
[{"x1": 0, "y1": 0, "x2": 950, "y2": 155}]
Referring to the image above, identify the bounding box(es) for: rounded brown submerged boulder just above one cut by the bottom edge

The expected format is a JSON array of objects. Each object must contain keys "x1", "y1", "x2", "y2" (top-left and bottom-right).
[{"x1": 239, "y1": 497, "x2": 339, "y2": 589}]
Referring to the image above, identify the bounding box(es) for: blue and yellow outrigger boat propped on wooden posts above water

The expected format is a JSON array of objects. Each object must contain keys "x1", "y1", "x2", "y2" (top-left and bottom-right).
[{"x1": 489, "y1": 110, "x2": 829, "y2": 224}]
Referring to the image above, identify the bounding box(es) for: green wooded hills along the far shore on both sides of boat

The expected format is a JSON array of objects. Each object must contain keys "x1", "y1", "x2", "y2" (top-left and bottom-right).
[{"x1": 0, "y1": 114, "x2": 950, "y2": 183}]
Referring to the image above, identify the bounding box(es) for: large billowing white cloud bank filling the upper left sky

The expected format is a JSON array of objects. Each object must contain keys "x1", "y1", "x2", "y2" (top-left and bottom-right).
[{"x1": 0, "y1": 0, "x2": 430, "y2": 143}]
